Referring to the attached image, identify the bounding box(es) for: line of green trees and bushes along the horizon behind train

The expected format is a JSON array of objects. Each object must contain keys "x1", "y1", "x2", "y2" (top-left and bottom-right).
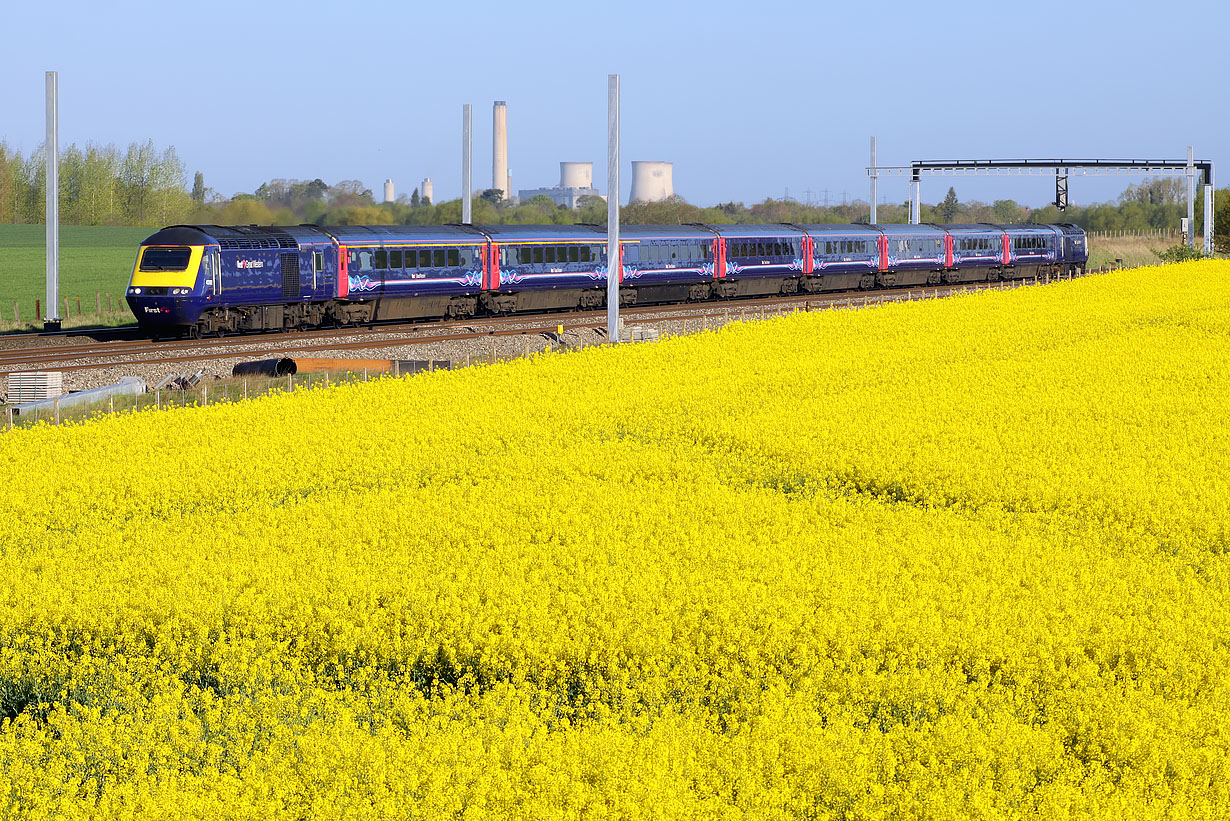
[{"x1": 0, "y1": 140, "x2": 1230, "y2": 251}]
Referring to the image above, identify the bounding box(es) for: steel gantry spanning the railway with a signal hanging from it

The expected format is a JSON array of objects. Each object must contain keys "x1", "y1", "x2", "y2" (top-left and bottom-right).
[{"x1": 867, "y1": 137, "x2": 1214, "y2": 254}]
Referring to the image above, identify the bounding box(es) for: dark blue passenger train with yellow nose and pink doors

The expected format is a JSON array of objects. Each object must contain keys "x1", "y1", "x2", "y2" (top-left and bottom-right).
[{"x1": 125, "y1": 224, "x2": 1089, "y2": 338}]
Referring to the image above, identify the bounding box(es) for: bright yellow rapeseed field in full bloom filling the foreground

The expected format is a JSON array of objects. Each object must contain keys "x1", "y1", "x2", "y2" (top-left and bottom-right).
[{"x1": 0, "y1": 262, "x2": 1230, "y2": 819}]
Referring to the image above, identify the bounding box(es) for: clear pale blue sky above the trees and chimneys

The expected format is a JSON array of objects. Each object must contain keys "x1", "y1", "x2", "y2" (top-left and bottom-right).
[{"x1": 0, "y1": 0, "x2": 1230, "y2": 206}]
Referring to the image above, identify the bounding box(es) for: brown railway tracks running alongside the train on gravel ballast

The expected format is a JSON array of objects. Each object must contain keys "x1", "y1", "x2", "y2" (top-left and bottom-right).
[{"x1": 0, "y1": 281, "x2": 1032, "y2": 373}]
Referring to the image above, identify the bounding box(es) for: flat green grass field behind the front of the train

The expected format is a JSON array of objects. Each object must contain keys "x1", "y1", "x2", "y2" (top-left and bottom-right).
[{"x1": 0, "y1": 225, "x2": 155, "y2": 330}]
